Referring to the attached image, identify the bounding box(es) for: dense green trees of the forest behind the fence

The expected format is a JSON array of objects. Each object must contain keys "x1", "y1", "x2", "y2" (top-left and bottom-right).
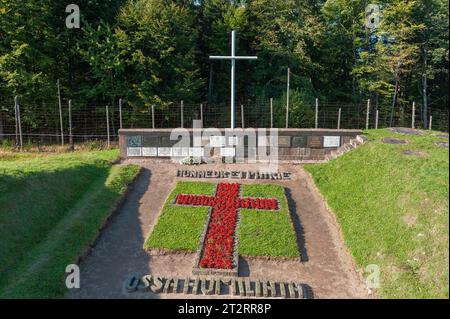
[{"x1": 0, "y1": 0, "x2": 449, "y2": 131}]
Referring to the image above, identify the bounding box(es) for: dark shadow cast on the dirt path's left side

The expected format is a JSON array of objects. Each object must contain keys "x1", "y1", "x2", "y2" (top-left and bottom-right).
[{"x1": 67, "y1": 168, "x2": 155, "y2": 299}]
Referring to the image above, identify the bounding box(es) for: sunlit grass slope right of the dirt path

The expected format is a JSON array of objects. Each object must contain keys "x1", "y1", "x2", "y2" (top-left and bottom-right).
[{"x1": 305, "y1": 130, "x2": 449, "y2": 298}]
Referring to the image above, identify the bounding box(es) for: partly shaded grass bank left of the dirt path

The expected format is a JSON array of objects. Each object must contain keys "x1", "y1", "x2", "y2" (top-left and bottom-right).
[{"x1": 0, "y1": 150, "x2": 139, "y2": 298}]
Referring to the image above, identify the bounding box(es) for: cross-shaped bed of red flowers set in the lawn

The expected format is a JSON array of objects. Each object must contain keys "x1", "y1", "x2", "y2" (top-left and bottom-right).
[{"x1": 175, "y1": 183, "x2": 278, "y2": 269}]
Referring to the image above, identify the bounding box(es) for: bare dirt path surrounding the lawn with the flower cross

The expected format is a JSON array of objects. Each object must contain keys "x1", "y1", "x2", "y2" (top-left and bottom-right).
[{"x1": 67, "y1": 161, "x2": 368, "y2": 298}]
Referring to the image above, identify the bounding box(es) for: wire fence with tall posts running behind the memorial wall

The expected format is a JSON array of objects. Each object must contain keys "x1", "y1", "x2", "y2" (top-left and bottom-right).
[{"x1": 0, "y1": 101, "x2": 449, "y2": 145}]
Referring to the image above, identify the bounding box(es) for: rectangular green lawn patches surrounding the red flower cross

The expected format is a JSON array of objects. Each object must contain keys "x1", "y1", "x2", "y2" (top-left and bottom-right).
[{"x1": 144, "y1": 182, "x2": 299, "y2": 257}]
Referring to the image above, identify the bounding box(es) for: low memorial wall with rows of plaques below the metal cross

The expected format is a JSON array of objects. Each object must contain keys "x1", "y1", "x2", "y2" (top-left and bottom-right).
[{"x1": 119, "y1": 129, "x2": 362, "y2": 163}]
